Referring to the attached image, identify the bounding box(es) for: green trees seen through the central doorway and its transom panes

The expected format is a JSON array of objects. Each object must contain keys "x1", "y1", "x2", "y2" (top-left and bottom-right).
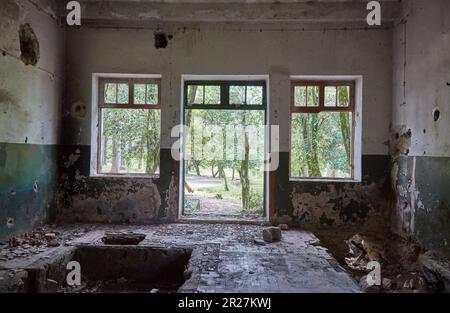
[{"x1": 185, "y1": 85, "x2": 265, "y2": 213}]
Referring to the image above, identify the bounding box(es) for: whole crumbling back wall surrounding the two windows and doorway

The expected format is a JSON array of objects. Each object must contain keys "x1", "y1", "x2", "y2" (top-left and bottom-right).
[{"x1": 57, "y1": 21, "x2": 392, "y2": 227}]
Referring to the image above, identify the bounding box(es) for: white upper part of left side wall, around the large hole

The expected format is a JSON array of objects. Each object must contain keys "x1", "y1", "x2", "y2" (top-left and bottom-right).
[{"x1": 0, "y1": 0, "x2": 64, "y2": 144}]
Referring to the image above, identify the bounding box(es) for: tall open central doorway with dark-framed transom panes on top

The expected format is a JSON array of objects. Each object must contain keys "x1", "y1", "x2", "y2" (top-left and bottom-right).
[{"x1": 182, "y1": 81, "x2": 267, "y2": 221}]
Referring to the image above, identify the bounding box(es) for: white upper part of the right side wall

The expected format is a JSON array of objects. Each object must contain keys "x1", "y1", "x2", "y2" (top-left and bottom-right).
[{"x1": 393, "y1": 0, "x2": 450, "y2": 157}]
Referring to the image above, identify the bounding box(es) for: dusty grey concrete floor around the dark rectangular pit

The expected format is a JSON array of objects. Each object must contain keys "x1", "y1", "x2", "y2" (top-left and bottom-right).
[{"x1": 0, "y1": 224, "x2": 361, "y2": 293}]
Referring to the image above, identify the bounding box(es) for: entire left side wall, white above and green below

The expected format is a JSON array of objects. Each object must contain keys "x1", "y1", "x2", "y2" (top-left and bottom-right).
[{"x1": 0, "y1": 0, "x2": 64, "y2": 239}]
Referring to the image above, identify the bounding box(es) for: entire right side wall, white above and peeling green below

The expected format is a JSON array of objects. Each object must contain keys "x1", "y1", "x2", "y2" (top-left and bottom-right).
[{"x1": 391, "y1": 0, "x2": 450, "y2": 256}]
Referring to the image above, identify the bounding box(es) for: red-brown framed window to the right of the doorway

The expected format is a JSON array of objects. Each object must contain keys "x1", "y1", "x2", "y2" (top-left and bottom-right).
[{"x1": 290, "y1": 81, "x2": 355, "y2": 179}]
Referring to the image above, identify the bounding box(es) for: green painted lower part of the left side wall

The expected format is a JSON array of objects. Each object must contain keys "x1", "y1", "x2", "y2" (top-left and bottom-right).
[{"x1": 0, "y1": 143, "x2": 57, "y2": 240}]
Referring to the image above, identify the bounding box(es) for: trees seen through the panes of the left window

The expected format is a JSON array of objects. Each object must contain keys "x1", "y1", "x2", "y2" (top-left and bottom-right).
[{"x1": 101, "y1": 83, "x2": 161, "y2": 174}]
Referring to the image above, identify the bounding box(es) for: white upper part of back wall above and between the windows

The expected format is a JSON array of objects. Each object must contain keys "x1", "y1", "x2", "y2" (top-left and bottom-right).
[{"x1": 63, "y1": 24, "x2": 392, "y2": 154}]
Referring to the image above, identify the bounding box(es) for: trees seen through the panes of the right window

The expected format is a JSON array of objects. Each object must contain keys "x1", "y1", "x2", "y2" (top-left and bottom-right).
[{"x1": 291, "y1": 86, "x2": 353, "y2": 178}]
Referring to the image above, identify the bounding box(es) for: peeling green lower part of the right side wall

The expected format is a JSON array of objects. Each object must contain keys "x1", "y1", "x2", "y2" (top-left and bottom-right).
[{"x1": 393, "y1": 156, "x2": 450, "y2": 257}]
